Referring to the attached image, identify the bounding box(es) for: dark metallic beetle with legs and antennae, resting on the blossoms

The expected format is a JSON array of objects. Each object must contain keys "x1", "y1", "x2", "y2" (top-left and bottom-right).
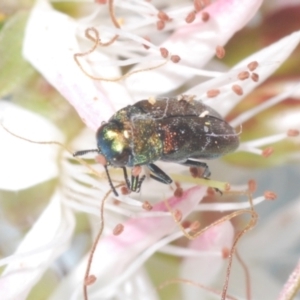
[{"x1": 73, "y1": 96, "x2": 239, "y2": 196}]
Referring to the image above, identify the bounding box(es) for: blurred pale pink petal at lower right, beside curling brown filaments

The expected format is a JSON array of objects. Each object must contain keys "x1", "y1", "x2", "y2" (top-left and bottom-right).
[{"x1": 180, "y1": 221, "x2": 234, "y2": 300}]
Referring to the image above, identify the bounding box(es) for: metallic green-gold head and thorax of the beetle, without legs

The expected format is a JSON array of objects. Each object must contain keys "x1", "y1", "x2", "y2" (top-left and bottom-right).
[{"x1": 97, "y1": 106, "x2": 163, "y2": 167}]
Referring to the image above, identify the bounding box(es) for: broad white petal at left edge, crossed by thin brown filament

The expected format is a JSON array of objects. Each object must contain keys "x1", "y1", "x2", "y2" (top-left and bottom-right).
[{"x1": 0, "y1": 100, "x2": 62, "y2": 191}]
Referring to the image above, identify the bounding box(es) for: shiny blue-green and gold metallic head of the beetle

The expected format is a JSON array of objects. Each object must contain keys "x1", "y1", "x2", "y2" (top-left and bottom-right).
[{"x1": 97, "y1": 122, "x2": 131, "y2": 166}]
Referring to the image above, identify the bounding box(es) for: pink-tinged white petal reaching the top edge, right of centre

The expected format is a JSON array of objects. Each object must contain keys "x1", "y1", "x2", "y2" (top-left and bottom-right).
[{"x1": 170, "y1": 0, "x2": 262, "y2": 51}]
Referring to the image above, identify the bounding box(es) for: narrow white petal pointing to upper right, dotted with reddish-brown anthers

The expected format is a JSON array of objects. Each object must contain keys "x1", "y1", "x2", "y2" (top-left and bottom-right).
[{"x1": 189, "y1": 31, "x2": 300, "y2": 118}]
